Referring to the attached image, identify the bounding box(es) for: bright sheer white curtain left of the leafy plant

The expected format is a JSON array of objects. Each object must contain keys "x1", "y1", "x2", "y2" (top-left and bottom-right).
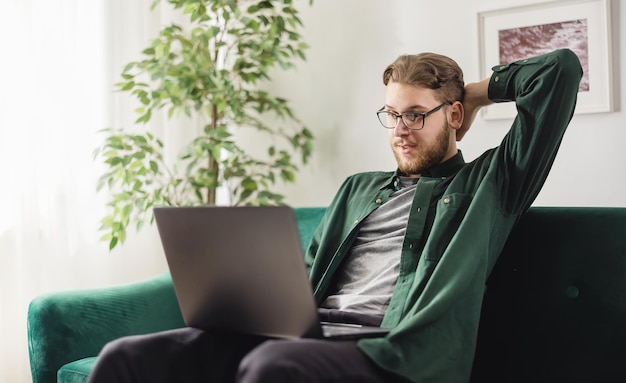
[{"x1": 0, "y1": 0, "x2": 188, "y2": 383}]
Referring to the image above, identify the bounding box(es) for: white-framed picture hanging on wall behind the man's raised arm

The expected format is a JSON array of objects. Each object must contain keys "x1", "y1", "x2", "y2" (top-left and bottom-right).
[{"x1": 478, "y1": 0, "x2": 613, "y2": 119}]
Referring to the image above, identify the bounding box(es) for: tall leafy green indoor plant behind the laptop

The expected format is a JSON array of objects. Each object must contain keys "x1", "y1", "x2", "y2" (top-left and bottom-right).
[{"x1": 94, "y1": 0, "x2": 313, "y2": 249}]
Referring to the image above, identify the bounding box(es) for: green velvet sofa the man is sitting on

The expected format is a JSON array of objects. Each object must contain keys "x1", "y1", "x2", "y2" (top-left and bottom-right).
[{"x1": 28, "y1": 207, "x2": 626, "y2": 383}]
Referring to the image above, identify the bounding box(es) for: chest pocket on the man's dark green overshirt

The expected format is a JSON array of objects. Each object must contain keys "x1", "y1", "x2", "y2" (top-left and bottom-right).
[{"x1": 425, "y1": 193, "x2": 473, "y2": 261}]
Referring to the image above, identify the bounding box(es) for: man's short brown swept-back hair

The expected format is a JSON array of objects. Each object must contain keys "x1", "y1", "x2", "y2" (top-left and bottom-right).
[{"x1": 383, "y1": 52, "x2": 465, "y2": 102}]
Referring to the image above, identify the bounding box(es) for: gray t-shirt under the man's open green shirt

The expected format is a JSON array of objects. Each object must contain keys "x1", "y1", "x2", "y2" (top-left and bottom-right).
[{"x1": 321, "y1": 177, "x2": 418, "y2": 316}]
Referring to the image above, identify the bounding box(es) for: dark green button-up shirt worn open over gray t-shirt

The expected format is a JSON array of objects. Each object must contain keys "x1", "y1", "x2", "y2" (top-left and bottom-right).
[{"x1": 306, "y1": 49, "x2": 582, "y2": 383}]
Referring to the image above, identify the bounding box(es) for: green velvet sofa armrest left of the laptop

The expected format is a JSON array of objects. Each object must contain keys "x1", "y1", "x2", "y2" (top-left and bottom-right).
[{"x1": 27, "y1": 273, "x2": 184, "y2": 383}]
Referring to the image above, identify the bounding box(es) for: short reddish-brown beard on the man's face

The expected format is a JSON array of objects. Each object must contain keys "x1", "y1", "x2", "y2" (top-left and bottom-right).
[{"x1": 392, "y1": 122, "x2": 450, "y2": 176}]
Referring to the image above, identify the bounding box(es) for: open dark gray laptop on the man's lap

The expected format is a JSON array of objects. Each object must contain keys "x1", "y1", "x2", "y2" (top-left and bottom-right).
[{"x1": 154, "y1": 206, "x2": 388, "y2": 339}]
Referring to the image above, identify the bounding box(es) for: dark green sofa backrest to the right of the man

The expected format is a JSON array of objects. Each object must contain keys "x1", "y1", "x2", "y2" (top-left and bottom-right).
[{"x1": 472, "y1": 207, "x2": 626, "y2": 383}]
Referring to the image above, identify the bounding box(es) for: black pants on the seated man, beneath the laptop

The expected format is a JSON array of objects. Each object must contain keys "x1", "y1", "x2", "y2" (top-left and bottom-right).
[{"x1": 89, "y1": 312, "x2": 392, "y2": 383}]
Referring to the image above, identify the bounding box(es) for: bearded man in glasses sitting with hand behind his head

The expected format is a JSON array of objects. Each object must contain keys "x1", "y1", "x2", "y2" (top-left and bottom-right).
[{"x1": 90, "y1": 50, "x2": 582, "y2": 383}]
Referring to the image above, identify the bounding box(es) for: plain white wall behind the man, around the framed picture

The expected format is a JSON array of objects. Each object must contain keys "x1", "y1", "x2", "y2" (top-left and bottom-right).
[{"x1": 264, "y1": 0, "x2": 626, "y2": 206}]
